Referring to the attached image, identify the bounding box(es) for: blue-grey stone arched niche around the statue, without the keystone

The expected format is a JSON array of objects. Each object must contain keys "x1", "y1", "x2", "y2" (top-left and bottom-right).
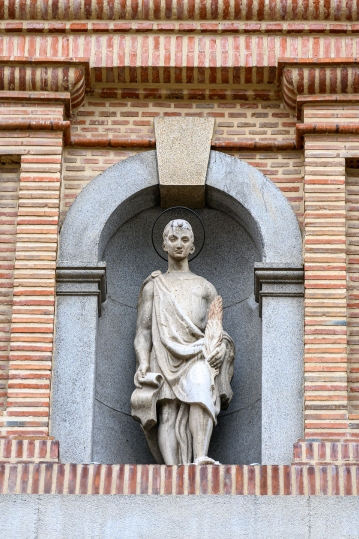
[{"x1": 51, "y1": 151, "x2": 302, "y2": 463}]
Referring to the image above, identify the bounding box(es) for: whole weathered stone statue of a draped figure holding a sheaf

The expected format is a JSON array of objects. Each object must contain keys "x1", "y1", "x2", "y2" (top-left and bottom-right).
[{"x1": 131, "y1": 219, "x2": 235, "y2": 465}]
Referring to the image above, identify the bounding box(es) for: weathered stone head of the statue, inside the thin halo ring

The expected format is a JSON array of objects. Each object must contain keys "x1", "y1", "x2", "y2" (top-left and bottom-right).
[{"x1": 162, "y1": 219, "x2": 195, "y2": 260}]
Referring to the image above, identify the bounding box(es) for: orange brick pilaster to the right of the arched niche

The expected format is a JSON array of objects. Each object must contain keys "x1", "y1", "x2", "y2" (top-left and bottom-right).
[{"x1": 304, "y1": 105, "x2": 359, "y2": 439}]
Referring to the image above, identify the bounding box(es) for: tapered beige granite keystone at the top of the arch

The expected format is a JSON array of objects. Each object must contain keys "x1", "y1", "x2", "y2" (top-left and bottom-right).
[{"x1": 155, "y1": 117, "x2": 214, "y2": 208}]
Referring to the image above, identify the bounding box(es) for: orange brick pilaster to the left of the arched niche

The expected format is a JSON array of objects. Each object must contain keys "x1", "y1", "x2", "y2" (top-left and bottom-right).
[{"x1": 0, "y1": 105, "x2": 63, "y2": 436}]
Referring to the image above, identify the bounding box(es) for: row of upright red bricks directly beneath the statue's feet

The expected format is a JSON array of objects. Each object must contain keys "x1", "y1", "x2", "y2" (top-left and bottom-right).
[{"x1": 0, "y1": 462, "x2": 359, "y2": 496}]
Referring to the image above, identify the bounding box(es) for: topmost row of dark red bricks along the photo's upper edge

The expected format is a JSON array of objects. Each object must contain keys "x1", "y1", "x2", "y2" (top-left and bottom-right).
[{"x1": 0, "y1": 0, "x2": 358, "y2": 22}]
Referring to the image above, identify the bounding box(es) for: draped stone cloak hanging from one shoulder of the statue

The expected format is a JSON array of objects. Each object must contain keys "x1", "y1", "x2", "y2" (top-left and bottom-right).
[{"x1": 131, "y1": 272, "x2": 234, "y2": 464}]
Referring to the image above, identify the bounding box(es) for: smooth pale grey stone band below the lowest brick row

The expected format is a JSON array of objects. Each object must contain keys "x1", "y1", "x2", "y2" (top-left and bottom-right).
[{"x1": 0, "y1": 495, "x2": 359, "y2": 539}]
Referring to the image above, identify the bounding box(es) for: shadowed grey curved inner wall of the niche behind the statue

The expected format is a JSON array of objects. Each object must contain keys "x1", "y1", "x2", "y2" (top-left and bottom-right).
[{"x1": 93, "y1": 207, "x2": 261, "y2": 464}]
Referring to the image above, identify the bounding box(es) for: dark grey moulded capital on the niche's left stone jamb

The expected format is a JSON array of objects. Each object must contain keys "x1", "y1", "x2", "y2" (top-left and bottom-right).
[{"x1": 56, "y1": 263, "x2": 107, "y2": 316}]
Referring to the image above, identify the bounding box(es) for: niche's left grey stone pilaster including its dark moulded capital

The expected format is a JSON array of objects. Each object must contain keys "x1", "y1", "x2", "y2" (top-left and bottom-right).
[{"x1": 50, "y1": 264, "x2": 106, "y2": 463}]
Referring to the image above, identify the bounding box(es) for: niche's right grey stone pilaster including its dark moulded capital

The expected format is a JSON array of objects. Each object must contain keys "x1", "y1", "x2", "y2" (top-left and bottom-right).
[{"x1": 254, "y1": 264, "x2": 304, "y2": 464}]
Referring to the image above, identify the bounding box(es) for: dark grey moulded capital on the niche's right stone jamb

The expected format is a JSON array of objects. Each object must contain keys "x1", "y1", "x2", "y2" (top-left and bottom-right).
[{"x1": 254, "y1": 264, "x2": 304, "y2": 316}]
